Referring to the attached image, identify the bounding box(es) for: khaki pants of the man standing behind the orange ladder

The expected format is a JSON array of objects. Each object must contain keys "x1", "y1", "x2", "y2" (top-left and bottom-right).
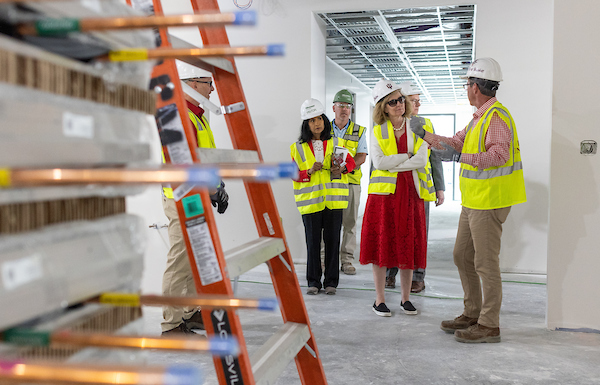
[{"x1": 161, "y1": 196, "x2": 197, "y2": 331}]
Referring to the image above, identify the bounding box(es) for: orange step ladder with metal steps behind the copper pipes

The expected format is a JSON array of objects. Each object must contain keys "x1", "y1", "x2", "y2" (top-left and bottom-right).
[{"x1": 128, "y1": 0, "x2": 327, "y2": 385}]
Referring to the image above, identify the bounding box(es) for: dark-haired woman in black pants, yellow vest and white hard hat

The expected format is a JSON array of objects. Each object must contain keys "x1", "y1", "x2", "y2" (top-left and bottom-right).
[{"x1": 290, "y1": 99, "x2": 355, "y2": 295}]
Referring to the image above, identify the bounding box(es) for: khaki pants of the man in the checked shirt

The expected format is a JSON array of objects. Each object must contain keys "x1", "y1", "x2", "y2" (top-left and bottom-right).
[{"x1": 454, "y1": 207, "x2": 510, "y2": 327}]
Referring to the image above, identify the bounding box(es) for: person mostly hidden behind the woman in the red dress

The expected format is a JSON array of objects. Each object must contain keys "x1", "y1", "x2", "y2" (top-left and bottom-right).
[{"x1": 385, "y1": 82, "x2": 446, "y2": 293}]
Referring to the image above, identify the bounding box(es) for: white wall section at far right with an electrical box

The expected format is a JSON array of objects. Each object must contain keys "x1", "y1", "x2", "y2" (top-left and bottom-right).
[{"x1": 547, "y1": 0, "x2": 600, "y2": 330}]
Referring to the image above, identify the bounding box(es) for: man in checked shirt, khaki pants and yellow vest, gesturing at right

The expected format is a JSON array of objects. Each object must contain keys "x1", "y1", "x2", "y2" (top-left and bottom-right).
[{"x1": 411, "y1": 58, "x2": 527, "y2": 342}]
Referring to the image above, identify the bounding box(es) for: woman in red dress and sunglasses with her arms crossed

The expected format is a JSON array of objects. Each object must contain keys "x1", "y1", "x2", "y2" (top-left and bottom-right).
[{"x1": 360, "y1": 79, "x2": 427, "y2": 317}]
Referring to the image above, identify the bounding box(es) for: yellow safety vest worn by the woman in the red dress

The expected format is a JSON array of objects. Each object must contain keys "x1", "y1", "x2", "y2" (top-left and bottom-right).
[{"x1": 369, "y1": 120, "x2": 435, "y2": 201}]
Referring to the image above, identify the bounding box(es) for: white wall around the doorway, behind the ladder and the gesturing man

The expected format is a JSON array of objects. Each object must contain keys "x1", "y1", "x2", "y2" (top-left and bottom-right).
[{"x1": 129, "y1": 0, "x2": 552, "y2": 292}]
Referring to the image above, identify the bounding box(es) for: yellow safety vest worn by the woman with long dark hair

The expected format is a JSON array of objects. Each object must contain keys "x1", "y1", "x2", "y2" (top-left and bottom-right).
[{"x1": 290, "y1": 137, "x2": 348, "y2": 215}]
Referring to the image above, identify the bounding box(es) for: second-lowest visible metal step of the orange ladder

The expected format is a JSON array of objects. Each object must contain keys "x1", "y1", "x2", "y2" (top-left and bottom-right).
[{"x1": 225, "y1": 237, "x2": 285, "y2": 279}]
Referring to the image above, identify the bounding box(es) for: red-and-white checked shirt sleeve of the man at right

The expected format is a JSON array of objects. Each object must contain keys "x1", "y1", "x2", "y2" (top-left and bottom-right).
[{"x1": 460, "y1": 114, "x2": 512, "y2": 170}]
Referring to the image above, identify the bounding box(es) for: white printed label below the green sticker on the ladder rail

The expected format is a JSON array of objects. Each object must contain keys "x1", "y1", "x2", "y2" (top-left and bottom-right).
[{"x1": 185, "y1": 217, "x2": 223, "y2": 286}]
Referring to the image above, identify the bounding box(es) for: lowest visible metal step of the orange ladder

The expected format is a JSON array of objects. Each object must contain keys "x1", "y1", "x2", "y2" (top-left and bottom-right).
[{"x1": 250, "y1": 322, "x2": 310, "y2": 385}]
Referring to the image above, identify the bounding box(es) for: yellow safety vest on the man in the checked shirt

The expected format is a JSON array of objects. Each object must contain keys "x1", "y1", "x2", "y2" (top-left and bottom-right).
[{"x1": 460, "y1": 102, "x2": 527, "y2": 210}]
